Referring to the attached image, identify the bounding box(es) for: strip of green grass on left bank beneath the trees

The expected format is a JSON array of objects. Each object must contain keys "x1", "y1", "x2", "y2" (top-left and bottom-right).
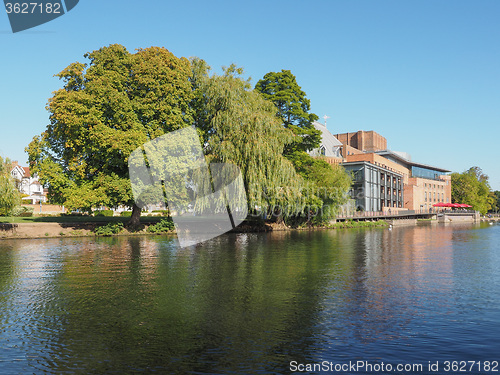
[{"x1": 0, "y1": 216, "x2": 163, "y2": 224}]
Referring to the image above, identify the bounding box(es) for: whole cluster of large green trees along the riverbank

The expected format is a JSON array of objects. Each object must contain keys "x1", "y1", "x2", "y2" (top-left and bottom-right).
[{"x1": 26, "y1": 45, "x2": 350, "y2": 224}]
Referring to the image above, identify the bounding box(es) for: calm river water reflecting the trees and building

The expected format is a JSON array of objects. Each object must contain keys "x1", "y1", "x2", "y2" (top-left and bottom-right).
[{"x1": 0, "y1": 225, "x2": 500, "y2": 374}]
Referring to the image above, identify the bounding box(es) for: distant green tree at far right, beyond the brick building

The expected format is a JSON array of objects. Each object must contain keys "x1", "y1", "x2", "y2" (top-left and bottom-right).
[{"x1": 451, "y1": 167, "x2": 495, "y2": 215}]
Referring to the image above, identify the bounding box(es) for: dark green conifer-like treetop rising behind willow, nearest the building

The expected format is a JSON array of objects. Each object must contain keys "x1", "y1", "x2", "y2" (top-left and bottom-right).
[{"x1": 255, "y1": 70, "x2": 321, "y2": 154}]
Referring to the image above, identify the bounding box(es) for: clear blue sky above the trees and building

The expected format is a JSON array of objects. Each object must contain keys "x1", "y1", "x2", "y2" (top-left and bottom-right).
[{"x1": 0, "y1": 0, "x2": 500, "y2": 190}]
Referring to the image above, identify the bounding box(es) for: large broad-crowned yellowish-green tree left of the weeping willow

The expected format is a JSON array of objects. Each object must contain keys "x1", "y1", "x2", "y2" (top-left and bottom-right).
[{"x1": 27, "y1": 44, "x2": 193, "y2": 224}]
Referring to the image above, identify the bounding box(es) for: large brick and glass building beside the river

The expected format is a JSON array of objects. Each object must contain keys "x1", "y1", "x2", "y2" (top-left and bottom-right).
[{"x1": 313, "y1": 123, "x2": 451, "y2": 211}]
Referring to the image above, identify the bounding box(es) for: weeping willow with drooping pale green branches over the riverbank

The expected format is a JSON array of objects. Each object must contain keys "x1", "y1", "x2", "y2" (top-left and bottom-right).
[{"x1": 192, "y1": 59, "x2": 306, "y2": 218}]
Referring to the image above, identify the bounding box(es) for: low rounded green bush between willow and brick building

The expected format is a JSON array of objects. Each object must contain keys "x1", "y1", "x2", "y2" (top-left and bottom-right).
[{"x1": 288, "y1": 151, "x2": 351, "y2": 224}]
